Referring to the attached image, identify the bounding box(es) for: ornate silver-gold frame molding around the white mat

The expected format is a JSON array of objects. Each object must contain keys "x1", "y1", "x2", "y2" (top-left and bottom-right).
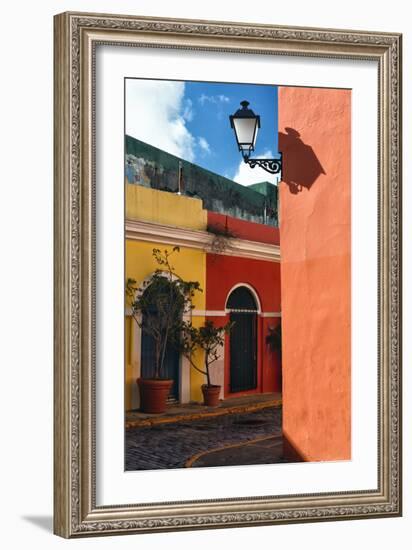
[{"x1": 54, "y1": 13, "x2": 402, "y2": 537}]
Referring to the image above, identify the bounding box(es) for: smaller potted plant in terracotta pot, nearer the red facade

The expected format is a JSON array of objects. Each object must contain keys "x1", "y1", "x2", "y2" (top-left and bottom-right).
[{"x1": 179, "y1": 320, "x2": 233, "y2": 407}]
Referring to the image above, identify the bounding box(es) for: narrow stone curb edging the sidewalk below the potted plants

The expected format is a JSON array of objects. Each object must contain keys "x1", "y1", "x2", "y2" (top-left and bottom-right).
[{"x1": 126, "y1": 399, "x2": 282, "y2": 430}]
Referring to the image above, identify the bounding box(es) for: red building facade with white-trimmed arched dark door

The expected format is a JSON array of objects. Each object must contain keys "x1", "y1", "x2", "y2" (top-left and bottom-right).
[{"x1": 206, "y1": 212, "x2": 282, "y2": 397}]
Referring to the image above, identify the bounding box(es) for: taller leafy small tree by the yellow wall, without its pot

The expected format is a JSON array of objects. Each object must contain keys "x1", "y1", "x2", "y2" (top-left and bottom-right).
[{"x1": 126, "y1": 246, "x2": 202, "y2": 378}]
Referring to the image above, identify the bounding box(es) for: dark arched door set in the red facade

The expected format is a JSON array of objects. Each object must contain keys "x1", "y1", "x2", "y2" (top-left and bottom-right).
[{"x1": 226, "y1": 286, "x2": 258, "y2": 392}]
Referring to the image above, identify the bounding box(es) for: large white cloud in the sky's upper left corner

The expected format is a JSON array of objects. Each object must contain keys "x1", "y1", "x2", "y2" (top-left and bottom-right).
[{"x1": 126, "y1": 79, "x2": 196, "y2": 162}]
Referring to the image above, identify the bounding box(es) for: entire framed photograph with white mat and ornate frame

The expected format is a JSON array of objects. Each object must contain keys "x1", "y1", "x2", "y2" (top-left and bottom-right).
[{"x1": 54, "y1": 13, "x2": 401, "y2": 537}]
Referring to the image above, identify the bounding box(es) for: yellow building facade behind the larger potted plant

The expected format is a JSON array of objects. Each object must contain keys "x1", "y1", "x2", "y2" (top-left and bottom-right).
[{"x1": 125, "y1": 182, "x2": 207, "y2": 410}]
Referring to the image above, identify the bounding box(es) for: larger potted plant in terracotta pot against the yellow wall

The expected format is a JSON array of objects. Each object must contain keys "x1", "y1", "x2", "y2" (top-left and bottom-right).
[{"x1": 126, "y1": 250, "x2": 201, "y2": 413}]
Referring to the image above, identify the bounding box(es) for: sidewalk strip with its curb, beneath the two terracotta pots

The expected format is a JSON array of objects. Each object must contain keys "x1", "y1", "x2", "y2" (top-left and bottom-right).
[{"x1": 126, "y1": 393, "x2": 282, "y2": 429}]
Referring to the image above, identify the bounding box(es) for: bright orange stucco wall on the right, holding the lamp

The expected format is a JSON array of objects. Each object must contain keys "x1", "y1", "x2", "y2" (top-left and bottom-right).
[{"x1": 279, "y1": 87, "x2": 351, "y2": 461}]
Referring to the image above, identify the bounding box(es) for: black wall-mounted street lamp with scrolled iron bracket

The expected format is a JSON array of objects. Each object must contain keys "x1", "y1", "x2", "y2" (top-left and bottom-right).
[{"x1": 229, "y1": 101, "x2": 282, "y2": 174}]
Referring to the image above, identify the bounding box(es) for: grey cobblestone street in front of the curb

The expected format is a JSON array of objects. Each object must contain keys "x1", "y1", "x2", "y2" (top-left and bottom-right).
[{"x1": 125, "y1": 407, "x2": 281, "y2": 470}]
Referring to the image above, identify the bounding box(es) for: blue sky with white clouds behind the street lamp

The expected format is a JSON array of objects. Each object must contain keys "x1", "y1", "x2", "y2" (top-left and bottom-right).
[{"x1": 126, "y1": 79, "x2": 278, "y2": 185}]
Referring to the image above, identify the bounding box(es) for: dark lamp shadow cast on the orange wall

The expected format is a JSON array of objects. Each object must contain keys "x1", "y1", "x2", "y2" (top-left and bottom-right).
[{"x1": 279, "y1": 128, "x2": 326, "y2": 194}]
